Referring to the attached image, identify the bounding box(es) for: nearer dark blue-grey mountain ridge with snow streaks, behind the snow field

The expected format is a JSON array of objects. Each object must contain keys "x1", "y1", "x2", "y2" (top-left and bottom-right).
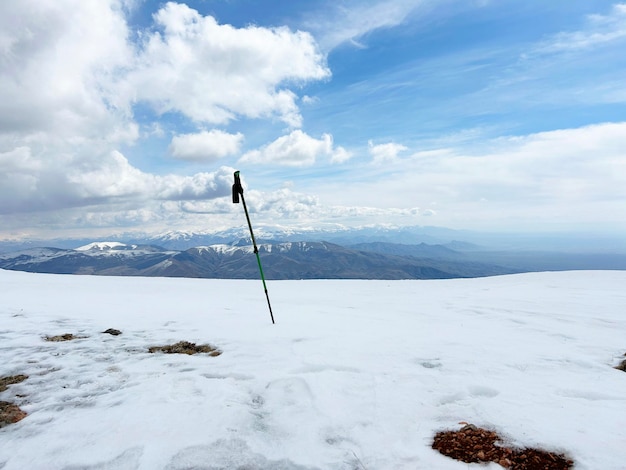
[{"x1": 0, "y1": 242, "x2": 514, "y2": 279}]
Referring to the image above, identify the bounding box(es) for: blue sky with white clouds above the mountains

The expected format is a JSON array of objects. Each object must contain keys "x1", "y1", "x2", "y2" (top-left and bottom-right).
[{"x1": 0, "y1": 0, "x2": 626, "y2": 240}]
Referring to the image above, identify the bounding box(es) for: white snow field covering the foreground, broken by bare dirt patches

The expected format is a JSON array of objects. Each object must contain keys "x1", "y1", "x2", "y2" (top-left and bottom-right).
[{"x1": 0, "y1": 270, "x2": 626, "y2": 470}]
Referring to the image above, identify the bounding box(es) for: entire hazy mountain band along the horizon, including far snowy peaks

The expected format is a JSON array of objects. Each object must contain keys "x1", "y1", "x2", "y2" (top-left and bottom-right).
[{"x1": 0, "y1": 226, "x2": 626, "y2": 279}]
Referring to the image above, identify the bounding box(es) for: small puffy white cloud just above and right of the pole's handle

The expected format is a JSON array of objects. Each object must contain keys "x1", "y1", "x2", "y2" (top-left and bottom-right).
[{"x1": 239, "y1": 129, "x2": 352, "y2": 167}]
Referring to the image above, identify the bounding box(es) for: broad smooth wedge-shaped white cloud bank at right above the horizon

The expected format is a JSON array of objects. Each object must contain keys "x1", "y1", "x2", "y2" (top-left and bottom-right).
[{"x1": 314, "y1": 122, "x2": 626, "y2": 230}]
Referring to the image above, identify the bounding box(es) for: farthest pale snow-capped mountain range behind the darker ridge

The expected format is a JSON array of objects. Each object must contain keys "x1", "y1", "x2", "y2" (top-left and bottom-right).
[{"x1": 0, "y1": 224, "x2": 626, "y2": 255}]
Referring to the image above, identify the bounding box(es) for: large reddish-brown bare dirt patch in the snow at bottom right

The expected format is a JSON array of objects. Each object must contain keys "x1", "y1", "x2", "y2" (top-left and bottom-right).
[{"x1": 432, "y1": 424, "x2": 574, "y2": 470}]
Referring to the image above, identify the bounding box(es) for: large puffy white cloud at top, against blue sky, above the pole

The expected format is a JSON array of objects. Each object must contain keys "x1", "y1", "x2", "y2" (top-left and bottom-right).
[{"x1": 126, "y1": 2, "x2": 330, "y2": 127}]
